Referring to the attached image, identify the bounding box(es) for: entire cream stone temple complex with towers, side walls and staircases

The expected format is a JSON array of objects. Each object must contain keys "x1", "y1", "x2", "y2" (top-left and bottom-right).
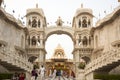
[{"x1": 0, "y1": 1, "x2": 120, "y2": 80}]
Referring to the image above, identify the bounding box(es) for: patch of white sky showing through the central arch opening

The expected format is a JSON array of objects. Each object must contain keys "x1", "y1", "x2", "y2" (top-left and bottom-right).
[{"x1": 45, "y1": 34, "x2": 74, "y2": 59}]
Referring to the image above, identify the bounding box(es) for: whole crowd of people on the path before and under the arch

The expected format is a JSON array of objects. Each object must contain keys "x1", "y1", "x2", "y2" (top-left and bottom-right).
[{"x1": 31, "y1": 65, "x2": 75, "y2": 80}]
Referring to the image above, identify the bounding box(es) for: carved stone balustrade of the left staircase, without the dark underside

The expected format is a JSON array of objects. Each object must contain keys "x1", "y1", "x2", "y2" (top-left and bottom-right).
[{"x1": 0, "y1": 47, "x2": 33, "y2": 71}]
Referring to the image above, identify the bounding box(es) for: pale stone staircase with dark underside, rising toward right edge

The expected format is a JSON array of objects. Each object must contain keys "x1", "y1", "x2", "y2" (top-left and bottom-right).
[{"x1": 85, "y1": 49, "x2": 120, "y2": 74}]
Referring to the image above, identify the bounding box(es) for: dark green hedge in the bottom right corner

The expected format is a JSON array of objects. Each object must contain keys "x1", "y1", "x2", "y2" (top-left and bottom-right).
[{"x1": 94, "y1": 74, "x2": 120, "y2": 80}]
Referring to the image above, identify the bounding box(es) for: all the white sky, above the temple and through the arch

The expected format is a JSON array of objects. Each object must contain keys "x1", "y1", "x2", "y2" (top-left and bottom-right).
[{"x1": 2, "y1": 0, "x2": 120, "y2": 59}]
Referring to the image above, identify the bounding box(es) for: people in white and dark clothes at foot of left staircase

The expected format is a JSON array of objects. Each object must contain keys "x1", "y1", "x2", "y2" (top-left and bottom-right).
[{"x1": 31, "y1": 65, "x2": 45, "y2": 80}]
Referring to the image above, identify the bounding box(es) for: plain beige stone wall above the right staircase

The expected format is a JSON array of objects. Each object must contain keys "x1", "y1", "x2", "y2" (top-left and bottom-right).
[{"x1": 94, "y1": 13, "x2": 120, "y2": 51}]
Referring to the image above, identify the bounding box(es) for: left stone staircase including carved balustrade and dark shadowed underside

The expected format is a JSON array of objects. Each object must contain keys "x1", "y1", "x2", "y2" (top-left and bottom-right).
[{"x1": 0, "y1": 48, "x2": 33, "y2": 72}]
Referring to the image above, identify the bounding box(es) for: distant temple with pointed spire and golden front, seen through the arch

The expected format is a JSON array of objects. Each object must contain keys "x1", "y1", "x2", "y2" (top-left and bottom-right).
[{"x1": 45, "y1": 44, "x2": 74, "y2": 76}]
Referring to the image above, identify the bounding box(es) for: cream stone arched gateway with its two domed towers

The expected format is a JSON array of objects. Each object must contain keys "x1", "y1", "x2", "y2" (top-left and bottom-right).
[{"x1": 26, "y1": 6, "x2": 93, "y2": 75}]
